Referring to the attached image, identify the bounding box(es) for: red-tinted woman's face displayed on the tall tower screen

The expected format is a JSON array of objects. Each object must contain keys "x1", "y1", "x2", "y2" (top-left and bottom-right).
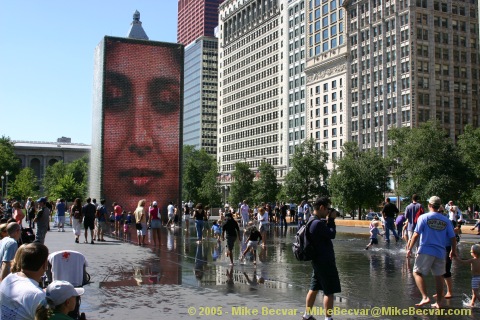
[{"x1": 102, "y1": 40, "x2": 182, "y2": 208}]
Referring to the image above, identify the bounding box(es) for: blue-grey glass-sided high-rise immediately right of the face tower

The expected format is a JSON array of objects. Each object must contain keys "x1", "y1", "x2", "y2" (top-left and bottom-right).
[{"x1": 183, "y1": 36, "x2": 218, "y2": 157}]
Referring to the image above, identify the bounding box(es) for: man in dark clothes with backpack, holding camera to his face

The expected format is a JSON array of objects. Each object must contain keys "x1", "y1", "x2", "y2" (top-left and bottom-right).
[{"x1": 302, "y1": 197, "x2": 341, "y2": 320}]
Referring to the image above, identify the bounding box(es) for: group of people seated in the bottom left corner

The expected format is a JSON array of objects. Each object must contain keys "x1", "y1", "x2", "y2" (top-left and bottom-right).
[{"x1": 0, "y1": 225, "x2": 84, "y2": 320}]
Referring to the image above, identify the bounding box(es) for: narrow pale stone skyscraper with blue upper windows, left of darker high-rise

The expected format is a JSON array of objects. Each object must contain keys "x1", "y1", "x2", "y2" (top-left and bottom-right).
[{"x1": 306, "y1": 0, "x2": 348, "y2": 167}]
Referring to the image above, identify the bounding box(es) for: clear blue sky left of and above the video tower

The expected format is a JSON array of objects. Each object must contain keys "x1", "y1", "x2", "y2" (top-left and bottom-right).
[{"x1": 0, "y1": 0, "x2": 178, "y2": 144}]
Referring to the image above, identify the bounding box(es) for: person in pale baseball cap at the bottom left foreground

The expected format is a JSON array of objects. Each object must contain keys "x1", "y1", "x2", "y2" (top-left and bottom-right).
[{"x1": 35, "y1": 280, "x2": 84, "y2": 320}]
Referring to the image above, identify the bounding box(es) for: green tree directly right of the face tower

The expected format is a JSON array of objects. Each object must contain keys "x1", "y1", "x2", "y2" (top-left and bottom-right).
[{"x1": 182, "y1": 145, "x2": 221, "y2": 206}]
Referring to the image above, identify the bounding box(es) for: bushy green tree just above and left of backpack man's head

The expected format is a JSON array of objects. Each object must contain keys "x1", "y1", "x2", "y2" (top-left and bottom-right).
[{"x1": 281, "y1": 139, "x2": 328, "y2": 200}]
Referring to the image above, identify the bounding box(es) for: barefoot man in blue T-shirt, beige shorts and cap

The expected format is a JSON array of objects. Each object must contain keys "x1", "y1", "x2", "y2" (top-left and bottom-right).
[{"x1": 407, "y1": 196, "x2": 457, "y2": 308}]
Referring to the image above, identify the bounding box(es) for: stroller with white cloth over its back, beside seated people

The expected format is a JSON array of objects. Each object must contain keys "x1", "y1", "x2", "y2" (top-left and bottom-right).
[{"x1": 43, "y1": 250, "x2": 90, "y2": 320}]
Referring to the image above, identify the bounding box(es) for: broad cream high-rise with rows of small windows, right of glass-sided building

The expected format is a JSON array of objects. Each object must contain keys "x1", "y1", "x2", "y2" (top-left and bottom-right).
[{"x1": 217, "y1": 0, "x2": 288, "y2": 183}]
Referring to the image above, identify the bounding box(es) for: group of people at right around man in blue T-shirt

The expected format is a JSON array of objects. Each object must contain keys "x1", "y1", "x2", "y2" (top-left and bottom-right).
[{"x1": 365, "y1": 194, "x2": 480, "y2": 308}]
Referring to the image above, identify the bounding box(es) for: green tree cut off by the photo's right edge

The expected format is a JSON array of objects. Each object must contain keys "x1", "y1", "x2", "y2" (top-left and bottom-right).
[{"x1": 457, "y1": 125, "x2": 480, "y2": 205}]
